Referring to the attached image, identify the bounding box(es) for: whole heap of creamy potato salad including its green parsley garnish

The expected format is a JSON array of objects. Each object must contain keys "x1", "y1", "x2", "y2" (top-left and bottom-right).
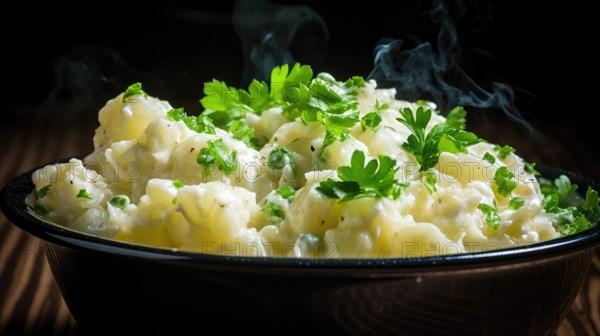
[{"x1": 28, "y1": 64, "x2": 598, "y2": 258}]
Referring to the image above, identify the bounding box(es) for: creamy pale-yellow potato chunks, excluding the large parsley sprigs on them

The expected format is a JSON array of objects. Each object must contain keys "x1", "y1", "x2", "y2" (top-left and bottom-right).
[{"x1": 29, "y1": 68, "x2": 559, "y2": 258}]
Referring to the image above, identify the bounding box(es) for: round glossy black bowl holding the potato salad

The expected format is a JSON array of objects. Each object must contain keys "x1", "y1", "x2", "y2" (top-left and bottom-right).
[{"x1": 0, "y1": 161, "x2": 600, "y2": 335}]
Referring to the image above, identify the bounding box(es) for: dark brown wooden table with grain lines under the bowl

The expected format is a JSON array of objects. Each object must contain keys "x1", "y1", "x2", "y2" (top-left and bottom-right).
[{"x1": 0, "y1": 114, "x2": 600, "y2": 336}]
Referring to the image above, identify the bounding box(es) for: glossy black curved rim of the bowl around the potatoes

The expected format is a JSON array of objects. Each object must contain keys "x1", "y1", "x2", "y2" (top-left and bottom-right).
[{"x1": 0, "y1": 157, "x2": 600, "y2": 271}]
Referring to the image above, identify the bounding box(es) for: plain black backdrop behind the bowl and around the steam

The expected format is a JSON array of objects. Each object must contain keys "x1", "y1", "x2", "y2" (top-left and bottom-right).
[{"x1": 0, "y1": 1, "x2": 600, "y2": 179}]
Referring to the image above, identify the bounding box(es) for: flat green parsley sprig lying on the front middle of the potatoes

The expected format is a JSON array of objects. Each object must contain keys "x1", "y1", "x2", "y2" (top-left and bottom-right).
[{"x1": 316, "y1": 150, "x2": 406, "y2": 202}]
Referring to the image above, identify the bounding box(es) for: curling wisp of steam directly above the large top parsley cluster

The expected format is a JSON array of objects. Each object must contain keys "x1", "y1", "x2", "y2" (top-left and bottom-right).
[{"x1": 233, "y1": 0, "x2": 329, "y2": 85}]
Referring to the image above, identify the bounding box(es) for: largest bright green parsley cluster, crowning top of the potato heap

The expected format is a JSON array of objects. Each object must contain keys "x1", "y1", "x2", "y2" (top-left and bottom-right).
[{"x1": 201, "y1": 63, "x2": 365, "y2": 148}]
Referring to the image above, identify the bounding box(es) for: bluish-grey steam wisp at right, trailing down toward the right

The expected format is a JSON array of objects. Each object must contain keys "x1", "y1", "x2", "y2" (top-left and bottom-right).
[{"x1": 368, "y1": 1, "x2": 535, "y2": 134}]
